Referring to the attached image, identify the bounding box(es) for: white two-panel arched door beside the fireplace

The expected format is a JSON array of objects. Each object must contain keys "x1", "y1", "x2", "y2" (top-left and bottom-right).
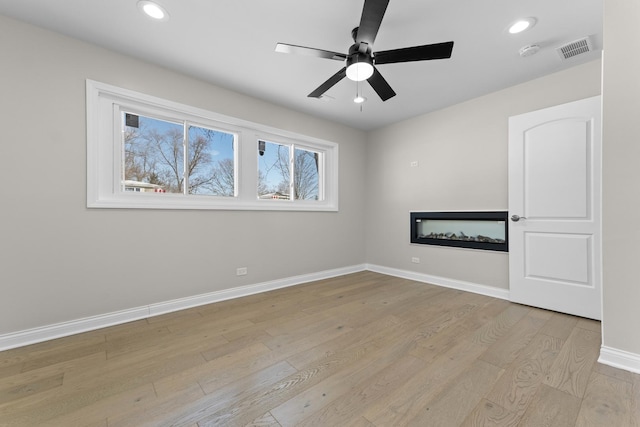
[{"x1": 509, "y1": 96, "x2": 601, "y2": 319}]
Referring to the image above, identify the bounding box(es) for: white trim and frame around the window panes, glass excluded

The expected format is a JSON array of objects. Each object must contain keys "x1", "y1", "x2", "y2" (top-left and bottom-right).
[{"x1": 86, "y1": 80, "x2": 338, "y2": 211}]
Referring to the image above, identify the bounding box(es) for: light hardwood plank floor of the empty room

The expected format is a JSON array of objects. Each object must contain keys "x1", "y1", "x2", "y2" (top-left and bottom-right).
[{"x1": 0, "y1": 272, "x2": 640, "y2": 427}]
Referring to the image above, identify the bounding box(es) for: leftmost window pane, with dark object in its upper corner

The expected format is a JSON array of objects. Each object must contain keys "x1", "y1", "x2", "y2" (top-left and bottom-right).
[{"x1": 122, "y1": 113, "x2": 184, "y2": 193}]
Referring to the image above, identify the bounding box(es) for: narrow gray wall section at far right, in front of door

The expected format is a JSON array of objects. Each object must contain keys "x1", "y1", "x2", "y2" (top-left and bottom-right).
[{"x1": 602, "y1": 0, "x2": 640, "y2": 356}]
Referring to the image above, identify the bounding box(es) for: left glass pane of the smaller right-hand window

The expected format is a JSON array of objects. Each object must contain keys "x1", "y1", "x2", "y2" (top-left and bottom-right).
[{"x1": 258, "y1": 141, "x2": 291, "y2": 200}]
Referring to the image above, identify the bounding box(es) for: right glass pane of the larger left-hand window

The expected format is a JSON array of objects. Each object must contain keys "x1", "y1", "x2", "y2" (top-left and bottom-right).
[{"x1": 189, "y1": 126, "x2": 236, "y2": 197}]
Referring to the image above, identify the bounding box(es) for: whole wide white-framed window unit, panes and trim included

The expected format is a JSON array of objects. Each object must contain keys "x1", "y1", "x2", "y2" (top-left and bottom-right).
[{"x1": 87, "y1": 80, "x2": 338, "y2": 211}]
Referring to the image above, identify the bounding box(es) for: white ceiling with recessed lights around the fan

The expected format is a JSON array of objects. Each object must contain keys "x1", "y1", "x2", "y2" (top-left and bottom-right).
[{"x1": 0, "y1": 0, "x2": 602, "y2": 130}]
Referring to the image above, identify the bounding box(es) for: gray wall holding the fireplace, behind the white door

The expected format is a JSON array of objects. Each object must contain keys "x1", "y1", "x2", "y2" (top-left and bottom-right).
[{"x1": 366, "y1": 59, "x2": 601, "y2": 289}]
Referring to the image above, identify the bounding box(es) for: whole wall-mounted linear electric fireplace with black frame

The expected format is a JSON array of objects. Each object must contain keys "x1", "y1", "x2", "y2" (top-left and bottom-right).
[{"x1": 411, "y1": 211, "x2": 509, "y2": 252}]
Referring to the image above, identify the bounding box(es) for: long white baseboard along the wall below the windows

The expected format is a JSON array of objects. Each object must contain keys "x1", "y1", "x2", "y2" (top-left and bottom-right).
[{"x1": 0, "y1": 264, "x2": 366, "y2": 351}]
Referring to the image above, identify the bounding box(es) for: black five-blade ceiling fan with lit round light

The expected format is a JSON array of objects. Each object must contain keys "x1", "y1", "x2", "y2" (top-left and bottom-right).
[{"x1": 276, "y1": 0, "x2": 453, "y2": 101}]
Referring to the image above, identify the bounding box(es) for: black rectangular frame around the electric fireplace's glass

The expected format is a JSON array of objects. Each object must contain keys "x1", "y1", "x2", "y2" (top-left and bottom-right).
[{"x1": 411, "y1": 211, "x2": 509, "y2": 252}]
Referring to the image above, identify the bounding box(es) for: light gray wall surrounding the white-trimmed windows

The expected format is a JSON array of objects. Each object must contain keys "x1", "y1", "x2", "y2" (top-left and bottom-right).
[{"x1": 0, "y1": 16, "x2": 366, "y2": 334}]
